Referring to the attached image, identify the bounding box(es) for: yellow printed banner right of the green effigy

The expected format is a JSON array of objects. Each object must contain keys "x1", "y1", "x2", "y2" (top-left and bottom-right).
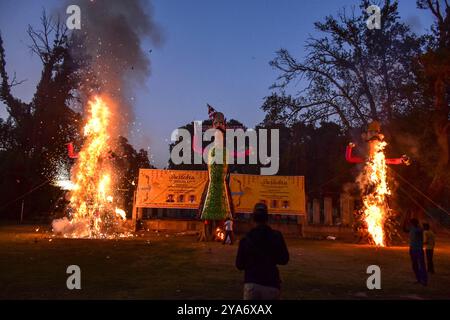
[{"x1": 230, "y1": 174, "x2": 305, "y2": 214}]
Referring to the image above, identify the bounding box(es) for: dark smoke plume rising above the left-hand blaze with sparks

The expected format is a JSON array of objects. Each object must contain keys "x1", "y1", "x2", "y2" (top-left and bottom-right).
[{"x1": 63, "y1": 0, "x2": 161, "y2": 134}]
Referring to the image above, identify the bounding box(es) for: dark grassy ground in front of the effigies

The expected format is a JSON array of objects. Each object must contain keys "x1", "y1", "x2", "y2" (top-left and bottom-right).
[{"x1": 0, "y1": 226, "x2": 450, "y2": 299}]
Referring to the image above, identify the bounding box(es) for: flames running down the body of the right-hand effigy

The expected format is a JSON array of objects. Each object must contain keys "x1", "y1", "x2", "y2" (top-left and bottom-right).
[{"x1": 359, "y1": 141, "x2": 391, "y2": 247}]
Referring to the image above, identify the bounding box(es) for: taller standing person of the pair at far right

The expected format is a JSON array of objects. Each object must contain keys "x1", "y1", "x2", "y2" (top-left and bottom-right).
[{"x1": 409, "y1": 219, "x2": 428, "y2": 286}]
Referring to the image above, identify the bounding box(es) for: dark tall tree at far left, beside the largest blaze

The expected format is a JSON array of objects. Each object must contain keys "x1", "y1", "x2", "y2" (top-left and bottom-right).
[{"x1": 0, "y1": 12, "x2": 84, "y2": 218}]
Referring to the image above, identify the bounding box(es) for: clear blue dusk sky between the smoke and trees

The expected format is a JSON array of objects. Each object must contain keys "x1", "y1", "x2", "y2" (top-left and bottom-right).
[{"x1": 0, "y1": 0, "x2": 432, "y2": 167}]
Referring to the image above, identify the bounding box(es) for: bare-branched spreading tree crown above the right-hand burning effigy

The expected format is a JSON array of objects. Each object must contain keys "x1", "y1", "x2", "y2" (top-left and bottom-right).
[{"x1": 263, "y1": 0, "x2": 424, "y2": 129}]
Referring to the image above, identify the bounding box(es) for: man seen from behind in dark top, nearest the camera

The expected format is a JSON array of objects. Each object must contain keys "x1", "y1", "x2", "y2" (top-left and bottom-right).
[{"x1": 236, "y1": 203, "x2": 289, "y2": 300}]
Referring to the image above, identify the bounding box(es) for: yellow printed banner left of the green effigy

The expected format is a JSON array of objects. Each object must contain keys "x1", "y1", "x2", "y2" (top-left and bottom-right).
[{"x1": 136, "y1": 169, "x2": 208, "y2": 209}]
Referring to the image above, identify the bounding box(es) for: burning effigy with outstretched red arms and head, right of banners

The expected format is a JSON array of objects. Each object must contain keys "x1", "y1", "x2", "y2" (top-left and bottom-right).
[{"x1": 345, "y1": 121, "x2": 410, "y2": 247}]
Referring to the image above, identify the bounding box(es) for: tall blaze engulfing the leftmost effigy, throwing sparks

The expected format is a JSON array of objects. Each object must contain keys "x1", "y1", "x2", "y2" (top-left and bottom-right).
[{"x1": 53, "y1": 96, "x2": 130, "y2": 238}]
